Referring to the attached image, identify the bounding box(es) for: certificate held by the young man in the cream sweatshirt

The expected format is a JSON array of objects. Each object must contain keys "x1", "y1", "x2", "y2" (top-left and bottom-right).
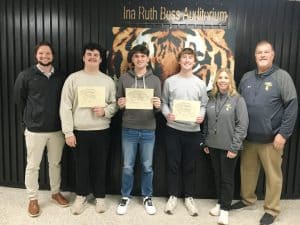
[{"x1": 77, "y1": 86, "x2": 105, "y2": 108}]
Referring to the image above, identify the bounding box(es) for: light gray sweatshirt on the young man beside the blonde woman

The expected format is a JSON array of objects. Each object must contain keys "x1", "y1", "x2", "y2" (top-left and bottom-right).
[{"x1": 162, "y1": 74, "x2": 208, "y2": 132}]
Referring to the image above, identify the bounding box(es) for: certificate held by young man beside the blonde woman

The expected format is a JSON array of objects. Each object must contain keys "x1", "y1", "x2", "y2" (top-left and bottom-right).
[{"x1": 173, "y1": 99, "x2": 201, "y2": 122}]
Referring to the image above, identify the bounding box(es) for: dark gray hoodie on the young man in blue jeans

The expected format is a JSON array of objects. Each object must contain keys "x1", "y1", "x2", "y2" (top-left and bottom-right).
[{"x1": 117, "y1": 70, "x2": 161, "y2": 130}]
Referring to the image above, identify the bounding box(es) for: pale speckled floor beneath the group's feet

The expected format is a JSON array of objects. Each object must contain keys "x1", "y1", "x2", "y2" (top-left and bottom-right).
[{"x1": 0, "y1": 187, "x2": 300, "y2": 225}]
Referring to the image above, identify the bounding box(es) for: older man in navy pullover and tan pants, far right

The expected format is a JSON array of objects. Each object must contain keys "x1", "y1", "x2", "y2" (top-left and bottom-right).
[{"x1": 231, "y1": 41, "x2": 298, "y2": 225}]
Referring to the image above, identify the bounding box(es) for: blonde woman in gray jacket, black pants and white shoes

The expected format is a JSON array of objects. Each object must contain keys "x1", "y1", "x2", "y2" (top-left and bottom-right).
[{"x1": 204, "y1": 68, "x2": 248, "y2": 224}]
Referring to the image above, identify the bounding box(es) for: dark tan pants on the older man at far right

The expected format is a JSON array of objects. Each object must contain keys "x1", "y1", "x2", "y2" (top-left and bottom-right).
[{"x1": 241, "y1": 141, "x2": 283, "y2": 216}]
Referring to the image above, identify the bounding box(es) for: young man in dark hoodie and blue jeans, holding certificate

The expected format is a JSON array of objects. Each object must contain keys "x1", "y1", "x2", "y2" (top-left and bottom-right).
[{"x1": 117, "y1": 45, "x2": 161, "y2": 215}]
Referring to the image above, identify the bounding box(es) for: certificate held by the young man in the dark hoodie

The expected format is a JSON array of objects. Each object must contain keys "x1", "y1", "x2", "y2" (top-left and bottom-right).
[{"x1": 125, "y1": 88, "x2": 154, "y2": 110}]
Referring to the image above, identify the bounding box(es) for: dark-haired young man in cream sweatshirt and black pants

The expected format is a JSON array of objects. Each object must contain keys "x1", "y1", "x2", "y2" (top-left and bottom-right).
[{"x1": 60, "y1": 43, "x2": 116, "y2": 214}]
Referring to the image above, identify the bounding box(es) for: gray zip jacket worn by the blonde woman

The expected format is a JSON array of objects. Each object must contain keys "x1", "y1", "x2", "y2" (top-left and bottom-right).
[{"x1": 205, "y1": 93, "x2": 249, "y2": 151}]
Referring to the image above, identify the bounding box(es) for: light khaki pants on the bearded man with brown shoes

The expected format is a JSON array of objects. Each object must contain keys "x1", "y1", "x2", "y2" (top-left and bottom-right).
[{"x1": 25, "y1": 129, "x2": 65, "y2": 200}]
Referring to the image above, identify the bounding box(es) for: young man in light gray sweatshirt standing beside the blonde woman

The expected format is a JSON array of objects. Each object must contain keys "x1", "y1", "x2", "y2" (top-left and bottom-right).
[{"x1": 162, "y1": 48, "x2": 208, "y2": 216}]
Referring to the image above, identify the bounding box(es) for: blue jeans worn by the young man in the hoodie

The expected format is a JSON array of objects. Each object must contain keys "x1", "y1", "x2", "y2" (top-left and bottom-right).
[{"x1": 121, "y1": 128, "x2": 155, "y2": 197}]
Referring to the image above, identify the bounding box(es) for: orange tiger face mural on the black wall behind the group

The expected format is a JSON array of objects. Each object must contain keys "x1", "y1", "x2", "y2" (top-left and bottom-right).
[{"x1": 109, "y1": 27, "x2": 234, "y2": 91}]
